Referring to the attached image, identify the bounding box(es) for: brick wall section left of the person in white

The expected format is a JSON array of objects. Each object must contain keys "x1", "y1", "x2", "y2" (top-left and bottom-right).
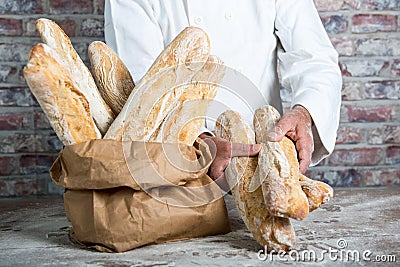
[{"x1": 0, "y1": 0, "x2": 104, "y2": 196}]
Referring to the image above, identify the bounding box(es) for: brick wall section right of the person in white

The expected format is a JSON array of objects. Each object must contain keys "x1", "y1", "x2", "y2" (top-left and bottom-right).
[{"x1": 309, "y1": 0, "x2": 400, "y2": 186}]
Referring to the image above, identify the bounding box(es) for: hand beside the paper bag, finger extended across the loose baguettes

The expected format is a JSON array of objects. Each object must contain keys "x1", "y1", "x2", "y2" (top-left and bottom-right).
[{"x1": 199, "y1": 133, "x2": 261, "y2": 188}]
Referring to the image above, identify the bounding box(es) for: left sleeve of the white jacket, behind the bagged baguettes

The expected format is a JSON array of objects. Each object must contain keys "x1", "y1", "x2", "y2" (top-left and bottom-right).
[{"x1": 104, "y1": 0, "x2": 164, "y2": 83}]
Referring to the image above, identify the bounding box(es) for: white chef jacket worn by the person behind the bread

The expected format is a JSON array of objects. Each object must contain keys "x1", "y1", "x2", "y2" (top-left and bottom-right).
[{"x1": 105, "y1": 0, "x2": 342, "y2": 164}]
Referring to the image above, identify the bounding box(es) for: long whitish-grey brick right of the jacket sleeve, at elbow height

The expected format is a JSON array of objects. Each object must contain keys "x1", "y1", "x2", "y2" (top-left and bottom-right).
[{"x1": 339, "y1": 59, "x2": 389, "y2": 77}]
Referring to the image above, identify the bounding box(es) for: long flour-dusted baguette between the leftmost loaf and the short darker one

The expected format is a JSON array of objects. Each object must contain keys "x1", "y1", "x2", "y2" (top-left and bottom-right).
[{"x1": 36, "y1": 19, "x2": 115, "y2": 134}]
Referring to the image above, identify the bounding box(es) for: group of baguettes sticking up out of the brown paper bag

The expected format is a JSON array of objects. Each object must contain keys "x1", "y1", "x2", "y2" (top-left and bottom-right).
[{"x1": 24, "y1": 19, "x2": 225, "y2": 145}]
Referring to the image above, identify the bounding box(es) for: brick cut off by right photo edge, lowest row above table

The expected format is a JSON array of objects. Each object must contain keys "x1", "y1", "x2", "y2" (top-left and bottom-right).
[{"x1": 364, "y1": 167, "x2": 400, "y2": 186}]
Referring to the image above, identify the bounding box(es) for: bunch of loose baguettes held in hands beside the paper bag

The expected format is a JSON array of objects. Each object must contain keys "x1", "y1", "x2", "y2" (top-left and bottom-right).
[{"x1": 216, "y1": 106, "x2": 333, "y2": 252}]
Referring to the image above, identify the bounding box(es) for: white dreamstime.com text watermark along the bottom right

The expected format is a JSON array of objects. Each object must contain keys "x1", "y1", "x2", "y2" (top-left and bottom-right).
[{"x1": 257, "y1": 239, "x2": 397, "y2": 262}]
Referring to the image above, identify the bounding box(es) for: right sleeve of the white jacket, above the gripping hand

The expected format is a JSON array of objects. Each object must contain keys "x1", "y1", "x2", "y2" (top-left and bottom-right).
[{"x1": 275, "y1": 0, "x2": 342, "y2": 164}]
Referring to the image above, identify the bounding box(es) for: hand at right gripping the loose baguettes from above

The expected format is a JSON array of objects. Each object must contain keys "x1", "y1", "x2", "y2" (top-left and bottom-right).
[{"x1": 268, "y1": 105, "x2": 314, "y2": 173}]
